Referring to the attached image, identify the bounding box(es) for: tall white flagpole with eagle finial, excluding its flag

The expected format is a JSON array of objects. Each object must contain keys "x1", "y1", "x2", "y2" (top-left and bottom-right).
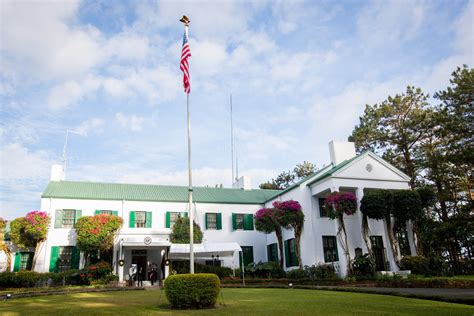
[{"x1": 180, "y1": 16, "x2": 194, "y2": 274}]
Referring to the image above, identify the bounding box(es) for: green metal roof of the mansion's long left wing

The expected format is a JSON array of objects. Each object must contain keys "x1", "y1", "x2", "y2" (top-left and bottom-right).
[{"x1": 41, "y1": 181, "x2": 281, "y2": 204}]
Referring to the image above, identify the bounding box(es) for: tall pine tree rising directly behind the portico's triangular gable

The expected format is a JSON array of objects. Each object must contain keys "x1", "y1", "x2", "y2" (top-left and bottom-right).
[{"x1": 349, "y1": 86, "x2": 432, "y2": 188}]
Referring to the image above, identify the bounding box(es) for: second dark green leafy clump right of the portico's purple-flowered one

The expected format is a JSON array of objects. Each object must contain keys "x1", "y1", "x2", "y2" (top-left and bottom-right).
[{"x1": 392, "y1": 190, "x2": 423, "y2": 223}]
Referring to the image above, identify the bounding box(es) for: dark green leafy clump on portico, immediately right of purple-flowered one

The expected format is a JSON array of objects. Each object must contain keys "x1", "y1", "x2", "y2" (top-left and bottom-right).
[{"x1": 360, "y1": 189, "x2": 393, "y2": 220}]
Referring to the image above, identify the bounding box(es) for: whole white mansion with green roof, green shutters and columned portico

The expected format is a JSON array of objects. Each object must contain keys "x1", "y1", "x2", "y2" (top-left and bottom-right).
[{"x1": 20, "y1": 142, "x2": 414, "y2": 281}]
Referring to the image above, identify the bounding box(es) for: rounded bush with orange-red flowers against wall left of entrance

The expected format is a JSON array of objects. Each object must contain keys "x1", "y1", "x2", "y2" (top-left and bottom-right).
[{"x1": 76, "y1": 214, "x2": 123, "y2": 254}]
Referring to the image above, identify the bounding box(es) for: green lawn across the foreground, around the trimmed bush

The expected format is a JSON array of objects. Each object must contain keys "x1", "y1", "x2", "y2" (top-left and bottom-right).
[{"x1": 0, "y1": 289, "x2": 474, "y2": 316}]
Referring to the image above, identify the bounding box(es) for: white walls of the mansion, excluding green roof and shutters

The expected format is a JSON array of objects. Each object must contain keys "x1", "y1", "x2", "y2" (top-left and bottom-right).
[{"x1": 36, "y1": 142, "x2": 409, "y2": 280}]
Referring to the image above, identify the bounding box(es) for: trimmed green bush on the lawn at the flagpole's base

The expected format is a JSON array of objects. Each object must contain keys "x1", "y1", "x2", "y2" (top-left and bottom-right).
[{"x1": 165, "y1": 273, "x2": 221, "y2": 309}]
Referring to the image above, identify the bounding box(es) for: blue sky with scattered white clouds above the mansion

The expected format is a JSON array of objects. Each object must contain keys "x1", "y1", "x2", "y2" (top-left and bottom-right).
[{"x1": 0, "y1": 0, "x2": 474, "y2": 219}]
